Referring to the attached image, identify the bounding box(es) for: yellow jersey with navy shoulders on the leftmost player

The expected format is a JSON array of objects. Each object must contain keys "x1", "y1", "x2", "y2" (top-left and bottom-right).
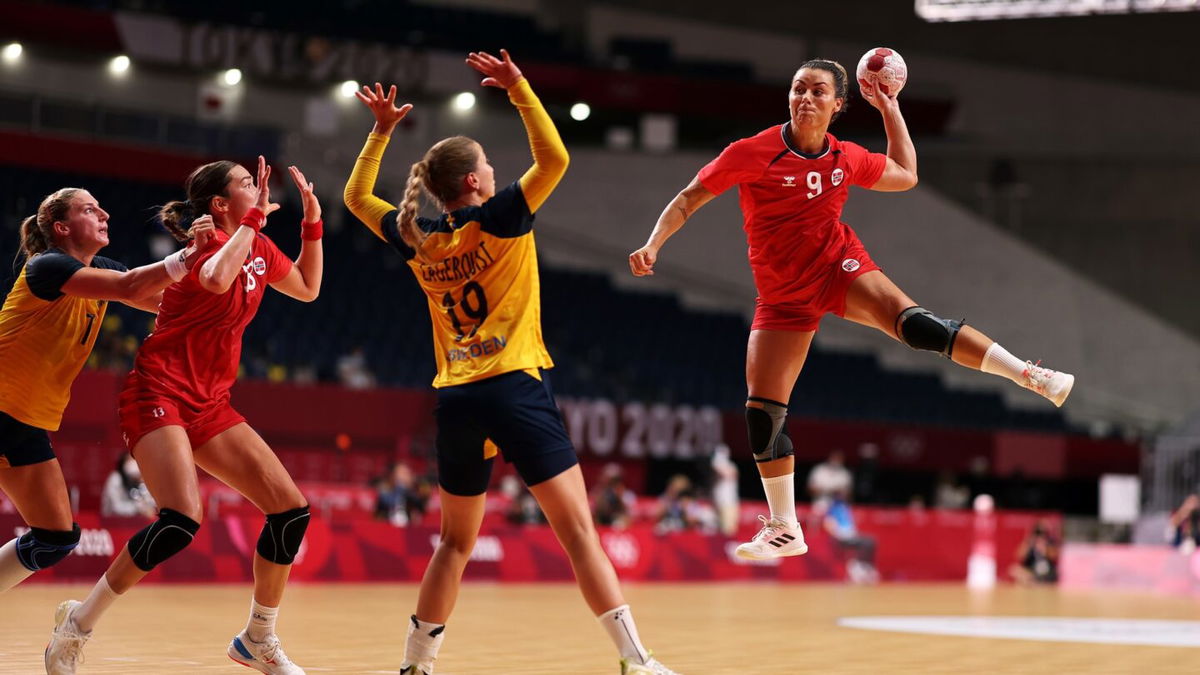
[{"x1": 0, "y1": 249, "x2": 125, "y2": 431}]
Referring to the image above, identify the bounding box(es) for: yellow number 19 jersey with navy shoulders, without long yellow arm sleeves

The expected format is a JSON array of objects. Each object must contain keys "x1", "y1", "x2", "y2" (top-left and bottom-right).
[{"x1": 379, "y1": 180, "x2": 554, "y2": 388}]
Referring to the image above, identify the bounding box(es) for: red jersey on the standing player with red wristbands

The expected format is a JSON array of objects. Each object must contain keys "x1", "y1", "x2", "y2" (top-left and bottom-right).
[{"x1": 133, "y1": 229, "x2": 293, "y2": 410}]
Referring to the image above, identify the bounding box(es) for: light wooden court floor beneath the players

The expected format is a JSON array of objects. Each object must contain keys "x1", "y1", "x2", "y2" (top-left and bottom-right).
[{"x1": 0, "y1": 584, "x2": 1200, "y2": 675}]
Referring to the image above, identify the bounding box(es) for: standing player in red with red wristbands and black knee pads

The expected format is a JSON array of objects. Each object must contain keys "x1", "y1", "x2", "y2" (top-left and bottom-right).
[{"x1": 46, "y1": 157, "x2": 323, "y2": 675}]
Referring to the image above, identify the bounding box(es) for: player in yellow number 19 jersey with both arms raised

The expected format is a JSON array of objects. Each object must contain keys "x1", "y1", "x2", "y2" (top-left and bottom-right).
[{"x1": 346, "y1": 49, "x2": 672, "y2": 675}]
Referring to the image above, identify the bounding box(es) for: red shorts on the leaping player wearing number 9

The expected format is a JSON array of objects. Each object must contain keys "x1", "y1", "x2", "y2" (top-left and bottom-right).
[{"x1": 750, "y1": 246, "x2": 880, "y2": 333}]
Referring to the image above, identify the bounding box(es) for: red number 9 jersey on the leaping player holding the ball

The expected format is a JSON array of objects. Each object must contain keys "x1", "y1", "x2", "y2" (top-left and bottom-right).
[{"x1": 698, "y1": 124, "x2": 887, "y2": 304}]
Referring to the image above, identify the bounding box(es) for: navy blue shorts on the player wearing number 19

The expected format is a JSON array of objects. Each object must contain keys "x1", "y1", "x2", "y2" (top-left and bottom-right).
[{"x1": 433, "y1": 370, "x2": 578, "y2": 497}]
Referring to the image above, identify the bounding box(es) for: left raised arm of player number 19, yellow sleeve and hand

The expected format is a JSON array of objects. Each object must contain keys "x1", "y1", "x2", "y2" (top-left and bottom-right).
[{"x1": 342, "y1": 82, "x2": 413, "y2": 240}]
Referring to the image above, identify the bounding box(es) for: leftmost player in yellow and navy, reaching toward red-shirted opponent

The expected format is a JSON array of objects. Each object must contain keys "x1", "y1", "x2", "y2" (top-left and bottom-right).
[{"x1": 0, "y1": 187, "x2": 212, "y2": 592}]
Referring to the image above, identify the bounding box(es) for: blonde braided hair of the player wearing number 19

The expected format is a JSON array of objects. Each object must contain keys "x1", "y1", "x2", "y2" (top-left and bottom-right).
[{"x1": 396, "y1": 136, "x2": 480, "y2": 263}]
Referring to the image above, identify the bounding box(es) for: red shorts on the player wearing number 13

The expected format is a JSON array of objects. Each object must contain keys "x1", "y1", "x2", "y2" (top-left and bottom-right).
[{"x1": 118, "y1": 372, "x2": 246, "y2": 453}]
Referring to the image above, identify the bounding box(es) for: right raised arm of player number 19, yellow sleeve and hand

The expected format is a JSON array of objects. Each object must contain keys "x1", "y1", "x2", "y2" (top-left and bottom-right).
[{"x1": 467, "y1": 49, "x2": 570, "y2": 213}]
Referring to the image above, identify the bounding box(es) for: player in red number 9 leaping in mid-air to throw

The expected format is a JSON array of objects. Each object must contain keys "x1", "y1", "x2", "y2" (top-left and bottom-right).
[{"x1": 629, "y1": 59, "x2": 1075, "y2": 560}]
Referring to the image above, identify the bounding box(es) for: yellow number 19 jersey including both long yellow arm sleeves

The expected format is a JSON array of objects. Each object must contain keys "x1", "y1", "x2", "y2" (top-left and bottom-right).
[{"x1": 346, "y1": 79, "x2": 568, "y2": 388}]
